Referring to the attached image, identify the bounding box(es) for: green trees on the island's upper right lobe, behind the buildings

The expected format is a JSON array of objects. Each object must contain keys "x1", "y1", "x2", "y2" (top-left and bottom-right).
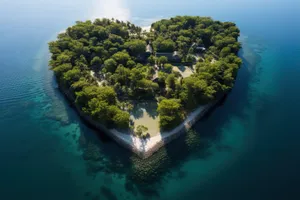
[{"x1": 151, "y1": 16, "x2": 240, "y2": 56}]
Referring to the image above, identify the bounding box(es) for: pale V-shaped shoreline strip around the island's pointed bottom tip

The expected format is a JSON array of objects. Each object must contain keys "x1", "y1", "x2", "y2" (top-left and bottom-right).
[{"x1": 58, "y1": 83, "x2": 223, "y2": 159}]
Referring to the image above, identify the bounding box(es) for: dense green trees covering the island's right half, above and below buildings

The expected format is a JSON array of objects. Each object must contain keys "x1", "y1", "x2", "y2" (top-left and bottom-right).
[{"x1": 151, "y1": 16, "x2": 241, "y2": 109}]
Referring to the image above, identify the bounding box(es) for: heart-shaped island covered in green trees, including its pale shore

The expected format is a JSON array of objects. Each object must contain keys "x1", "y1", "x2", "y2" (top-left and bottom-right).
[{"x1": 49, "y1": 16, "x2": 242, "y2": 158}]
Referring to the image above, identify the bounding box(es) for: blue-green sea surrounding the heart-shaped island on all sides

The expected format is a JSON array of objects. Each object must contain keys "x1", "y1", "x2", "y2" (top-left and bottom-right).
[{"x1": 0, "y1": 0, "x2": 300, "y2": 200}]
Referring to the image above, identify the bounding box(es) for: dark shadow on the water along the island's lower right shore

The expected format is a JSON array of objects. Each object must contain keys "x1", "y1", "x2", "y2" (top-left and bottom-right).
[{"x1": 121, "y1": 45, "x2": 257, "y2": 197}]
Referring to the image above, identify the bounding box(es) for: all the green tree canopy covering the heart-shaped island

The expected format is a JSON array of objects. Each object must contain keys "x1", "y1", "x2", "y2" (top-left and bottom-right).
[{"x1": 49, "y1": 16, "x2": 242, "y2": 132}]
